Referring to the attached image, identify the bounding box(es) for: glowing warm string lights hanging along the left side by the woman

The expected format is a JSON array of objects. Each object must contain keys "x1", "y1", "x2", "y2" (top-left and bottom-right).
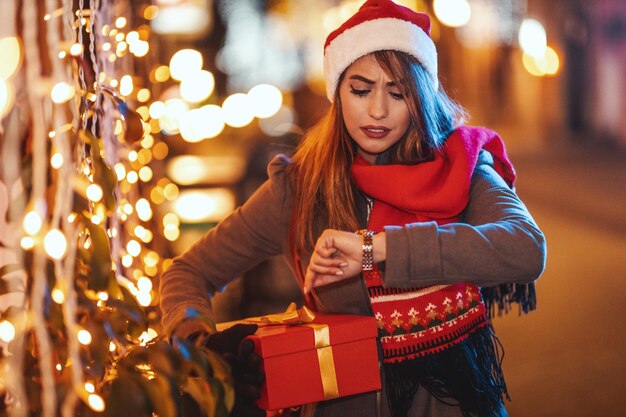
[{"x1": 0, "y1": 0, "x2": 240, "y2": 417}]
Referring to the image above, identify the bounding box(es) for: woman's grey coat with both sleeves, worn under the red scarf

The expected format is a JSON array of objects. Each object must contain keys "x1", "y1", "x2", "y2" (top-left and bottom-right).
[{"x1": 160, "y1": 156, "x2": 546, "y2": 417}]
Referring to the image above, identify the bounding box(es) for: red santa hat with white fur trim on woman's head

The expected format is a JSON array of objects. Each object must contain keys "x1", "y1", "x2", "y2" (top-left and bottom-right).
[{"x1": 324, "y1": 0, "x2": 439, "y2": 101}]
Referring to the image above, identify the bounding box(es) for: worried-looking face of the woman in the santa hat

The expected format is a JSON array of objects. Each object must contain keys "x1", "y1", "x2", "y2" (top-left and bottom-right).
[{"x1": 339, "y1": 55, "x2": 410, "y2": 164}]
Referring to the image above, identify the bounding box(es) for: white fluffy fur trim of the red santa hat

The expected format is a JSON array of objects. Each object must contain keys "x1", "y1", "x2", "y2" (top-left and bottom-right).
[{"x1": 324, "y1": 18, "x2": 439, "y2": 102}]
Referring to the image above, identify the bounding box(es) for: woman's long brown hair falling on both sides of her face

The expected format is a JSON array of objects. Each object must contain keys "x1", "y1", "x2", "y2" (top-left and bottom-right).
[{"x1": 289, "y1": 51, "x2": 465, "y2": 255}]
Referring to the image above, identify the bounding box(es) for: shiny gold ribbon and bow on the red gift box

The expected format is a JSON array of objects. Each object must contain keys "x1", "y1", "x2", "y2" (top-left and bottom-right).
[{"x1": 245, "y1": 303, "x2": 339, "y2": 400}]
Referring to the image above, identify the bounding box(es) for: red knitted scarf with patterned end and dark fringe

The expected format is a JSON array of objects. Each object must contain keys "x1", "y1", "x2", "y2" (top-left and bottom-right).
[{"x1": 352, "y1": 127, "x2": 534, "y2": 417}]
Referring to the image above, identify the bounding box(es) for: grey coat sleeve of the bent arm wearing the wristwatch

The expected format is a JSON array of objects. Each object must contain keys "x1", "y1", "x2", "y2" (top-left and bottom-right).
[{"x1": 384, "y1": 164, "x2": 546, "y2": 288}]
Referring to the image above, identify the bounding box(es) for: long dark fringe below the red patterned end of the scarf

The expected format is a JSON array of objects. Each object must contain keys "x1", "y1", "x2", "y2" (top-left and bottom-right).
[{"x1": 384, "y1": 325, "x2": 510, "y2": 417}]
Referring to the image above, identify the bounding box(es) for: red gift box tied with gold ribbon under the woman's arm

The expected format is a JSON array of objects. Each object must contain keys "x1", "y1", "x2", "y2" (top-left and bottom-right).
[{"x1": 218, "y1": 312, "x2": 380, "y2": 410}]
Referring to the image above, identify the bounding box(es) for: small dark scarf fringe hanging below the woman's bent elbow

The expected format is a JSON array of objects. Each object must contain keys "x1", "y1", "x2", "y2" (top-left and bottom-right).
[{"x1": 480, "y1": 282, "x2": 537, "y2": 318}]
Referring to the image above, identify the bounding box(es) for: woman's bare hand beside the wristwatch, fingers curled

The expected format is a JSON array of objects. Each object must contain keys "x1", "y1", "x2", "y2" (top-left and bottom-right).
[{"x1": 304, "y1": 229, "x2": 363, "y2": 293}]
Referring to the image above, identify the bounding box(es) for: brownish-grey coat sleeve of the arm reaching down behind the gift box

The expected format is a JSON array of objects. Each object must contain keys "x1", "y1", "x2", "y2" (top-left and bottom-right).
[{"x1": 159, "y1": 156, "x2": 290, "y2": 337}]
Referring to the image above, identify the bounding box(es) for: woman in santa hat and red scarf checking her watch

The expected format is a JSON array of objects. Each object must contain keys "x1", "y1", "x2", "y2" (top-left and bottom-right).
[{"x1": 161, "y1": 1, "x2": 545, "y2": 416}]
